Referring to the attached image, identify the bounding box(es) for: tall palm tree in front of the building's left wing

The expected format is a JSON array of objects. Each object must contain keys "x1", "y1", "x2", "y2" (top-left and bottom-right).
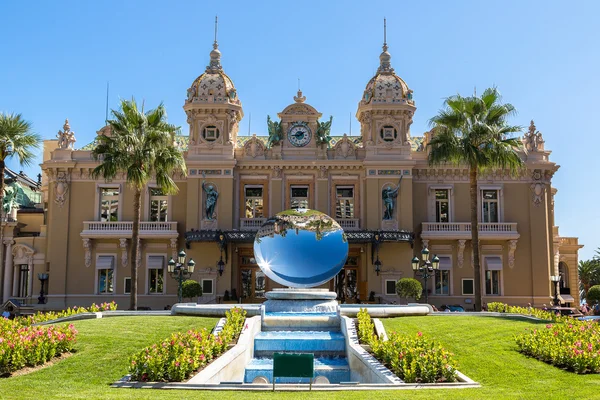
[{"x1": 92, "y1": 99, "x2": 186, "y2": 310}]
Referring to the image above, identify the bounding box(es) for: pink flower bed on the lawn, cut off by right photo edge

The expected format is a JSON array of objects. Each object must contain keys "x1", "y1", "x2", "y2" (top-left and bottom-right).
[{"x1": 515, "y1": 320, "x2": 600, "y2": 374}]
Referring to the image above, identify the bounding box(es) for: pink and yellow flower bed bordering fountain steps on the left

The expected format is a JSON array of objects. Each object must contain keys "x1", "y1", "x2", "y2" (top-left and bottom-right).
[{"x1": 129, "y1": 308, "x2": 246, "y2": 382}]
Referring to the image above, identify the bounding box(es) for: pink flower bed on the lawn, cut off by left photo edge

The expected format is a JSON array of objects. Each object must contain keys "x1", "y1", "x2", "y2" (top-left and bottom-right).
[{"x1": 0, "y1": 318, "x2": 77, "y2": 375}]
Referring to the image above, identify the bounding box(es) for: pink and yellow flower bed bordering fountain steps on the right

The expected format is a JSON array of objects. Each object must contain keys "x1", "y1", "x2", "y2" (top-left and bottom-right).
[{"x1": 357, "y1": 309, "x2": 457, "y2": 383}]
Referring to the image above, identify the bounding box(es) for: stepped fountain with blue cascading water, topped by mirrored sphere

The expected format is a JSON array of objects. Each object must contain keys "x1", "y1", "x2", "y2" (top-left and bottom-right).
[{"x1": 180, "y1": 209, "x2": 429, "y2": 385}]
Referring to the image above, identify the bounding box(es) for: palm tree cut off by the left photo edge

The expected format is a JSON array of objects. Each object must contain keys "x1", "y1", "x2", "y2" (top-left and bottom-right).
[{"x1": 0, "y1": 112, "x2": 42, "y2": 290}]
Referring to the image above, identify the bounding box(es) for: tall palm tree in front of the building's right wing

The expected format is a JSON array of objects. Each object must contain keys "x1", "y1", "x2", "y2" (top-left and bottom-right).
[{"x1": 427, "y1": 88, "x2": 523, "y2": 310}]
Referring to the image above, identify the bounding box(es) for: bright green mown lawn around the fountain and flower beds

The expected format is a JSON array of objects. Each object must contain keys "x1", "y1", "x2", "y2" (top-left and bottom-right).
[{"x1": 0, "y1": 316, "x2": 600, "y2": 400}]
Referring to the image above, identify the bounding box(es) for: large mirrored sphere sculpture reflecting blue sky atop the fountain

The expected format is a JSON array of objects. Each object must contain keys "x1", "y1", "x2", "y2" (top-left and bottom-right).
[{"x1": 254, "y1": 208, "x2": 348, "y2": 288}]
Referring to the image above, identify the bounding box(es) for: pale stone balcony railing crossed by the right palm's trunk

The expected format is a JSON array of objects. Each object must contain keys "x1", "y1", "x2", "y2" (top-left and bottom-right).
[{"x1": 421, "y1": 222, "x2": 520, "y2": 239}]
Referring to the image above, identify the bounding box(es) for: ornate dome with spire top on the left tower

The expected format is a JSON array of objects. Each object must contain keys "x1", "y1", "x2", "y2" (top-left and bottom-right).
[{"x1": 186, "y1": 40, "x2": 241, "y2": 104}]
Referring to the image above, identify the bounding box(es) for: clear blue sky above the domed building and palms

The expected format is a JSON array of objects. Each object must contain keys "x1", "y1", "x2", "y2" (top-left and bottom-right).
[{"x1": 0, "y1": 0, "x2": 600, "y2": 258}]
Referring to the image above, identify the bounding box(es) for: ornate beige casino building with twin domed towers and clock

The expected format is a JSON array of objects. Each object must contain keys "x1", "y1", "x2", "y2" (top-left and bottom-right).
[{"x1": 0, "y1": 32, "x2": 582, "y2": 309}]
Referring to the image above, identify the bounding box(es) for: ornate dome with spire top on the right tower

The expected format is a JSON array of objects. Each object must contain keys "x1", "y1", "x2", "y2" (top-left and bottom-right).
[{"x1": 361, "y1": 38, "x2": 414, "y2": 105}]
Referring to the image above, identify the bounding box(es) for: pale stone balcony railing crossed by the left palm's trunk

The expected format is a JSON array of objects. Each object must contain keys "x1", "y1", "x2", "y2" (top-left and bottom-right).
[{"x1": 81, "y1": 221, "x2": 179, "y2": 238}]
